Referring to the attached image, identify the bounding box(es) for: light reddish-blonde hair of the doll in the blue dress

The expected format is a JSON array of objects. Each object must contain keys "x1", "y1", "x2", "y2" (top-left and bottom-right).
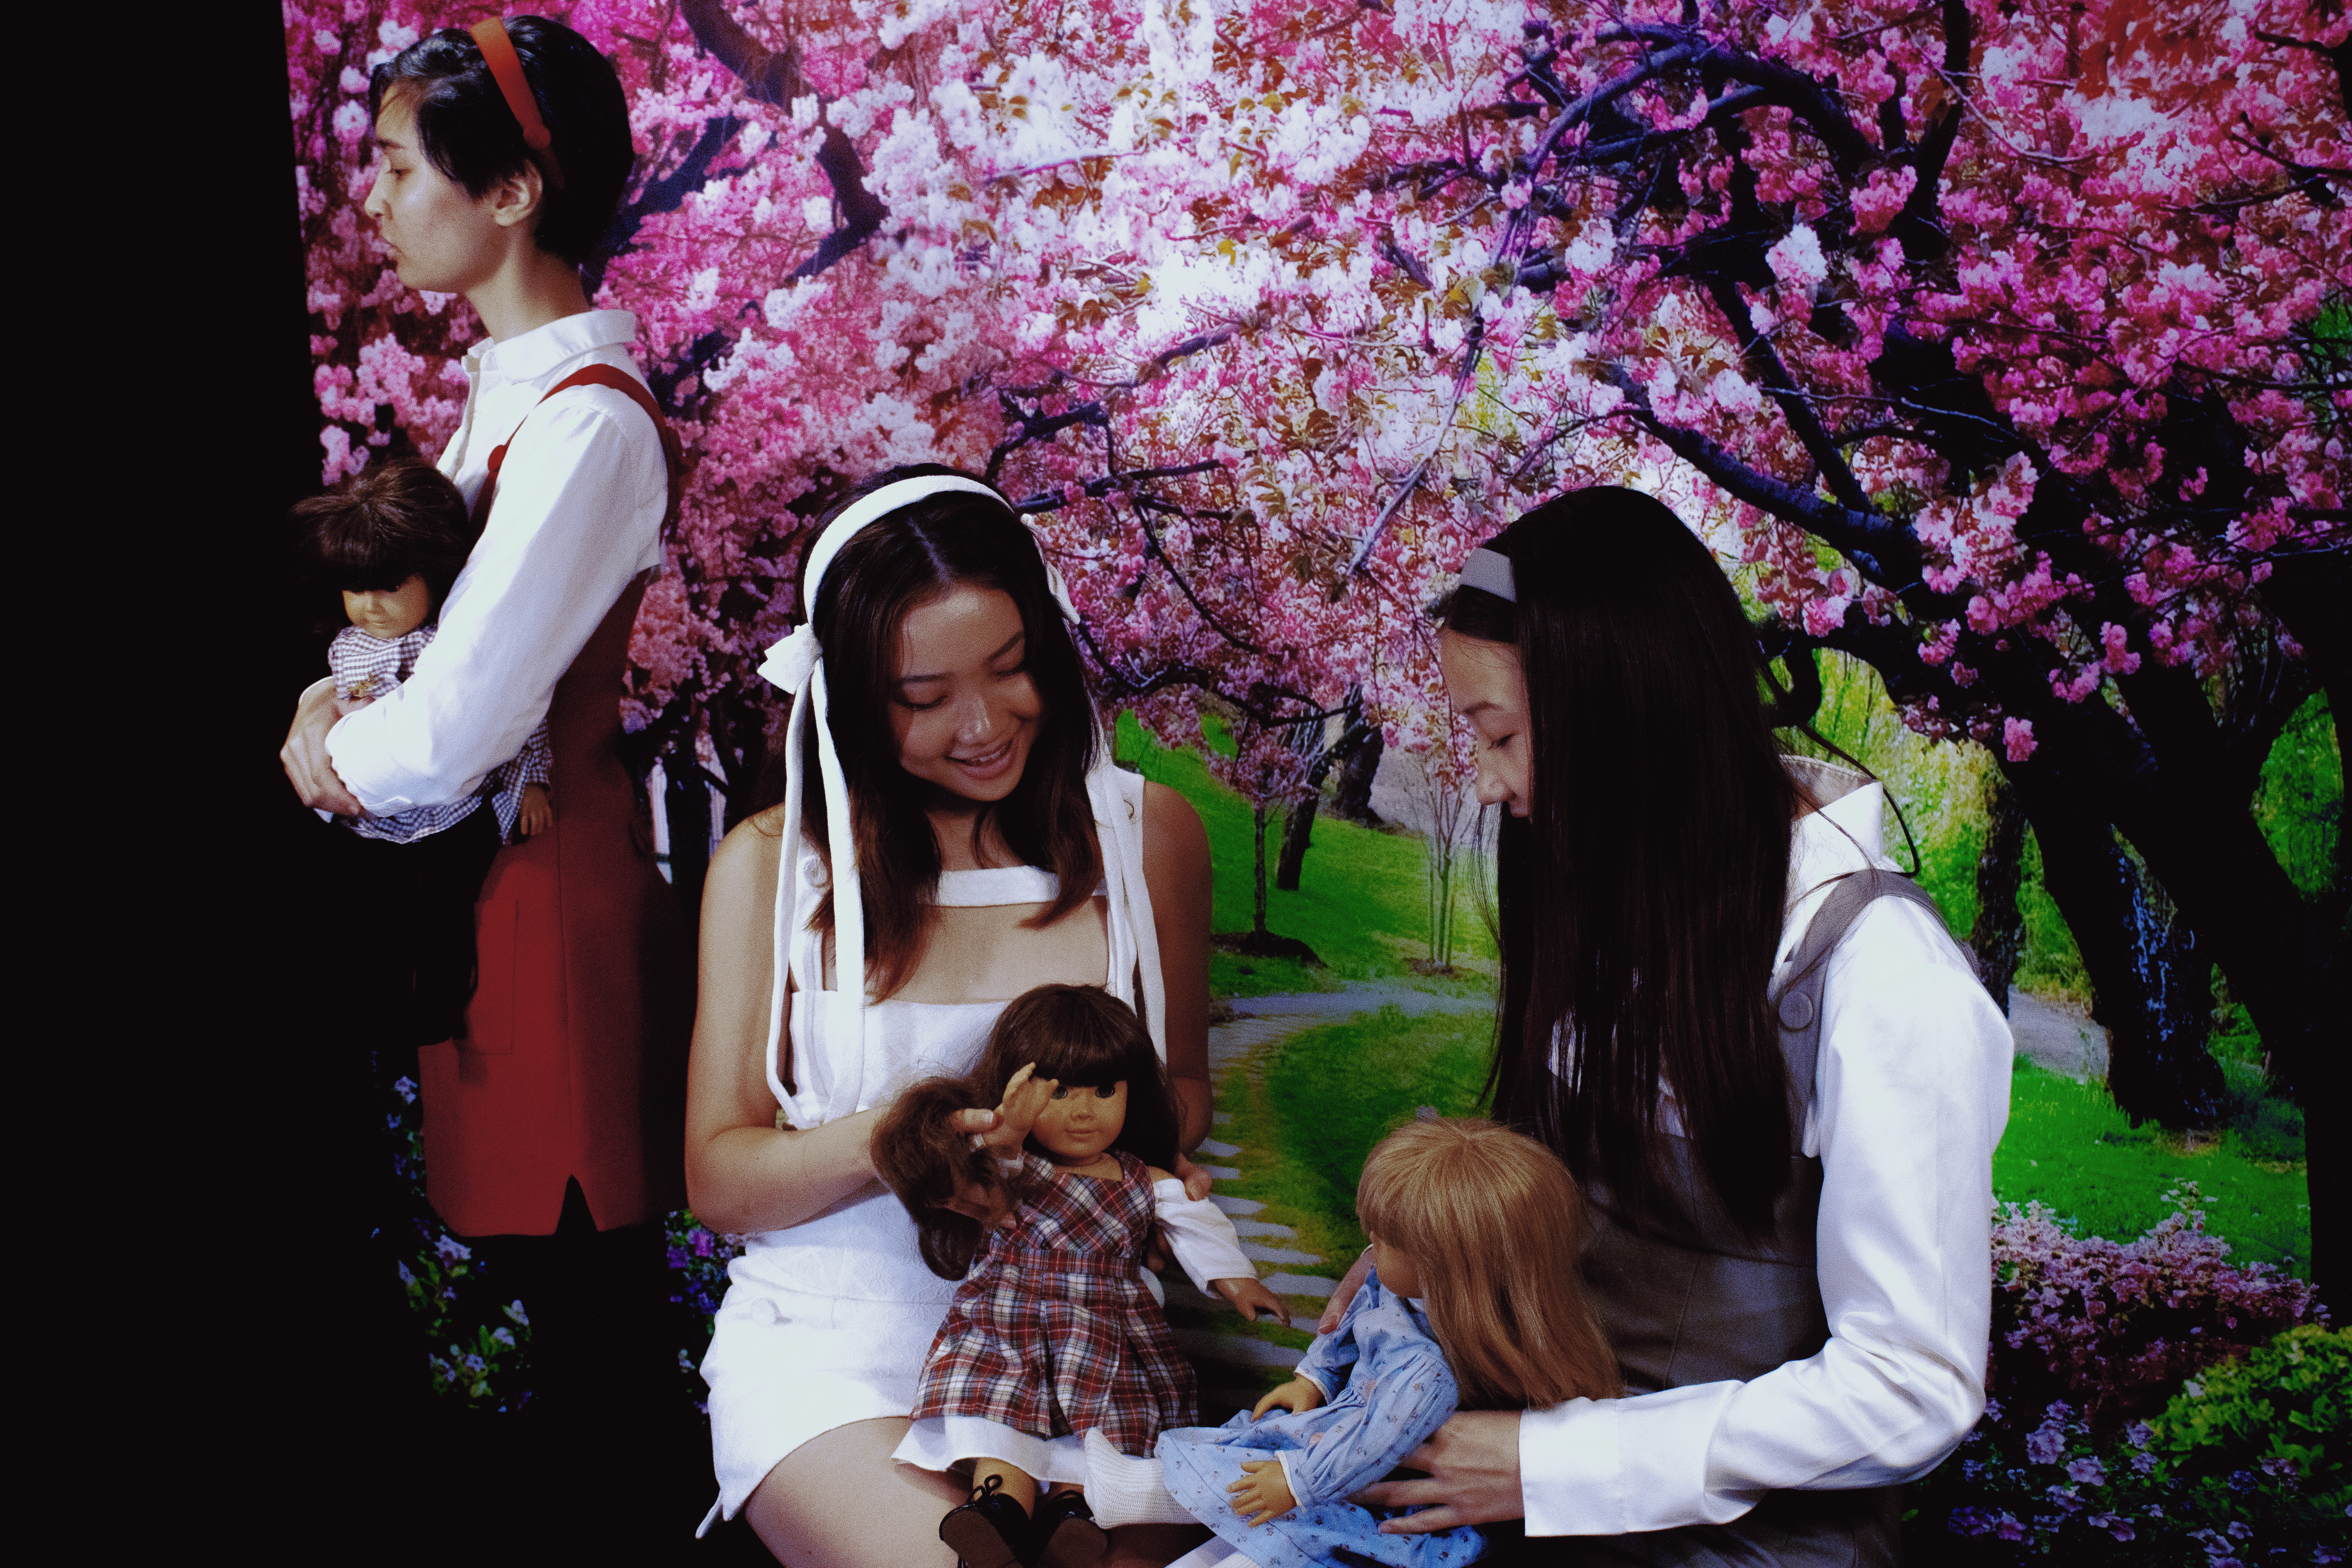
[{"x1": 1355, "y1": 1117, "x2": 1618, "y2": 1411}]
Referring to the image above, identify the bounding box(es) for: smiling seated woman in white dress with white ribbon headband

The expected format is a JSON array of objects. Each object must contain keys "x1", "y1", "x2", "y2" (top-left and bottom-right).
[{"x1": 687, "y1": 466, "x2": 1209, "y2": 1568}]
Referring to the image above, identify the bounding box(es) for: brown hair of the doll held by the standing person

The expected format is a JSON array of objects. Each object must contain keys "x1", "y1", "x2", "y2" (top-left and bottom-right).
[{"x1": 294, "y1": 459, "x2": 475, "y2": 616}]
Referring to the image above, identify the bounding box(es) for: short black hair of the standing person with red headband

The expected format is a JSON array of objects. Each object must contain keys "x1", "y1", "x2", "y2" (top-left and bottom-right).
[{"x1": 367, "y1": 16, "x2": 637, "y2": 266}]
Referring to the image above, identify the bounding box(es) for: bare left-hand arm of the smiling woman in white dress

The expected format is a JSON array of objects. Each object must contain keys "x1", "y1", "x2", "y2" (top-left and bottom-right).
[{"x1": 687, "y1": 808, "x2": 997, "y2": 1234}]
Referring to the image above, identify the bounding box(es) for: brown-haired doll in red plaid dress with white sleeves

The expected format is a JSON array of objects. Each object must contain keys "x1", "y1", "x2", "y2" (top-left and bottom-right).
[{"x1": 873, "y1": 985, "x2": 1286, "y2": 1568}]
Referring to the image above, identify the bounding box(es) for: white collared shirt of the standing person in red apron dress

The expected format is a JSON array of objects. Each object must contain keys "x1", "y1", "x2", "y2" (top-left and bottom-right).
[{"x1": 327, "y1": 310, "x2": 671, "y2": 816}]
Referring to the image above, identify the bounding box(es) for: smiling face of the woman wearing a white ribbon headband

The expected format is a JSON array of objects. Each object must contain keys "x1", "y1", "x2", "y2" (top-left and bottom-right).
[{"x1": 889, "y1": 583, "x2": 1044, "y2": 802}]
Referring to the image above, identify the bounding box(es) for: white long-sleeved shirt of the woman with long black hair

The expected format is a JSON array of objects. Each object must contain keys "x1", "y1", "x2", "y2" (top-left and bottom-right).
[{"x1": 1519, "y1": 776, "x2": 2013, "y2": 1535}]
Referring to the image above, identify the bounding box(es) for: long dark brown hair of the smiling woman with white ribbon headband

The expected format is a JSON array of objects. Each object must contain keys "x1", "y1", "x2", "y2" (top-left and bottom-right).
[{"x1": 755, "y1": 463, "x2": 1103, "y2": 1006}]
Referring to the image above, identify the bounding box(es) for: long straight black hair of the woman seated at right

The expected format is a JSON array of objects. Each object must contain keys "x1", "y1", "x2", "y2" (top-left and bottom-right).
[{"x1": 1444, "y1": 487, "x2": 1799, "y2": 1234}]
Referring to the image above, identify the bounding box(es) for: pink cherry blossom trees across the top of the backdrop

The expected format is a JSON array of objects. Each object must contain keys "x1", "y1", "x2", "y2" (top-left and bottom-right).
[{"x1": 285, "y1": 0, "x2": 2352, "y2": 1277}]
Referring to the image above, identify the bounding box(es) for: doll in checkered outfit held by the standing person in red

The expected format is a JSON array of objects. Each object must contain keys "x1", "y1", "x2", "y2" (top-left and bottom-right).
[{"x1": 294, "y1": 459, "x2": 555, "y2": 1046}]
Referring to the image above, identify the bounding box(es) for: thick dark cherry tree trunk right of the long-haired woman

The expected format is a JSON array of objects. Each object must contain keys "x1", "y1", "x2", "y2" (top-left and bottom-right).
[{"x1": 2013, "y1": 781, "x2": 2225, "y2": 1131}]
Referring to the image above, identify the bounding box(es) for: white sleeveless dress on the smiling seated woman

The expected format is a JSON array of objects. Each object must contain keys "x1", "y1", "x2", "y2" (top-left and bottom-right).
[{"x1": 701, "y1": 766, "x2": 1167, "y2": 1528}]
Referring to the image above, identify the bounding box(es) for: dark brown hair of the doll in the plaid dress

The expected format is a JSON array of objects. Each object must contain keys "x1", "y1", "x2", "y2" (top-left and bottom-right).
[{"x1": 870, "y1": 985, "x2": 1176, "y2": 1279}]
